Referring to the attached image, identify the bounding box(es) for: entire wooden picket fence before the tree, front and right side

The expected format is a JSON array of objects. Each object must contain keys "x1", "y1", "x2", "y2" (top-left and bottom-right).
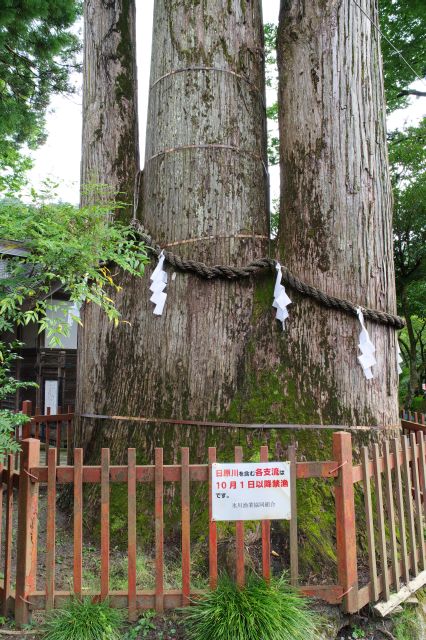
[{"x1": 0, "y1": 416, "x2": 426, "y2": 625}]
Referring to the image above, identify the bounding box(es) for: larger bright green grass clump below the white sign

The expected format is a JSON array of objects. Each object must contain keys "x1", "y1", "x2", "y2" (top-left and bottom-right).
[{"x1": 184, "y1": 575, "x2": 319, "y2": 640}]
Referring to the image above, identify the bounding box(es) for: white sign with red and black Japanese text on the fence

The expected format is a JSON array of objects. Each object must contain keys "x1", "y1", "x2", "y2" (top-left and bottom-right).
[{"x1": 212, "y1": 462, "x2": 291, "y2": 521}]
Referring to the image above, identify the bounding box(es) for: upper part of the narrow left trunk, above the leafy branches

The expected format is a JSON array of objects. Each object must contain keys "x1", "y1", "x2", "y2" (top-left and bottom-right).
[{"x1": 81, "y1": 0, "x2": 139, "y2": 220}]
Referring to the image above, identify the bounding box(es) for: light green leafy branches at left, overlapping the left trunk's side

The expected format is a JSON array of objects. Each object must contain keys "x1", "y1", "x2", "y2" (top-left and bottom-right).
[{"x1": 0, "y1": 182, "x2": 147, "y2": 344}]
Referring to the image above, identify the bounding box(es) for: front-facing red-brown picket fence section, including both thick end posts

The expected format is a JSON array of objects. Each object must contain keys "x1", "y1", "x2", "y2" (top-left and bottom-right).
[{"x1": 0, "y1": 433, "x2": 356, "y2": 624}]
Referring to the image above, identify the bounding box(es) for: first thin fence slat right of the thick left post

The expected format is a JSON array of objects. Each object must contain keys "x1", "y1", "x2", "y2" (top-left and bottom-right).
[{"x1": 46, "y1": 449, "x2": 56, "y2": 611}]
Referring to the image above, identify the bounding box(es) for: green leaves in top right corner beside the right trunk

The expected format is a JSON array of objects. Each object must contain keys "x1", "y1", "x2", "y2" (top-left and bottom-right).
[{"x1": 380, "y1": 0, "x2": 426, "y2": 111}]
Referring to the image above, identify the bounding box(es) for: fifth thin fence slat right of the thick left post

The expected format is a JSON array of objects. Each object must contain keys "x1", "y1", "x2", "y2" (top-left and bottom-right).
[{"x1": 155, "y1": 448, "x2": 164, "y2": 613}]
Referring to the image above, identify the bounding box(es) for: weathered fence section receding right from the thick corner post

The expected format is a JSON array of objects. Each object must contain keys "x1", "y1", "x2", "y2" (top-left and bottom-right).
[{"x1": 353, "y1": 431, "x2": 426, "y2": 615}]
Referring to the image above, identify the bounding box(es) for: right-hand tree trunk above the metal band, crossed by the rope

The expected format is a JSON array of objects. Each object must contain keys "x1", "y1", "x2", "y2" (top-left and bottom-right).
[{"x1": 278, "y1": 0, "x2": 398, "y2": 427}]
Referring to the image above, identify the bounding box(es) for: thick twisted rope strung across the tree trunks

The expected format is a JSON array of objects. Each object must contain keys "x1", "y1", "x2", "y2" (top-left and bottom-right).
[{"x1": 132, "y1": 220, "x2": 405, "y2": 329}]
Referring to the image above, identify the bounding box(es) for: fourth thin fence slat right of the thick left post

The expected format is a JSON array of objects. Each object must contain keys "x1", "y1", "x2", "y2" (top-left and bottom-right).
[{"x1": 127, "y1": 449, "x2": 138, "y2": 622}]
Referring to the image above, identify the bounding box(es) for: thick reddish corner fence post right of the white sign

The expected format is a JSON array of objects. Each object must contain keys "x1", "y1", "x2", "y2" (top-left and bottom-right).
[{"x1": 333, "y1": 431, "x2": 358, "y2": 613}]
